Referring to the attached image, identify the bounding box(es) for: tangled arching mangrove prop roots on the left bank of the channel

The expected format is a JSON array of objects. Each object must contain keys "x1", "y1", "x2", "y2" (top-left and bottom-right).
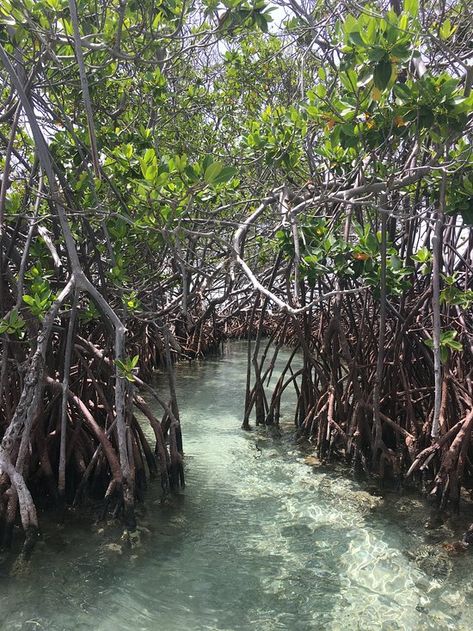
[{"x1": 0, "y1": 318, "x2": 196, "y2": 562}]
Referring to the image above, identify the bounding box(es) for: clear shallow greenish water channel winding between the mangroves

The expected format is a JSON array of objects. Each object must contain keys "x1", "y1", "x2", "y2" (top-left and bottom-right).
[{"x1": 0, "y1": 344, "x2": 473, "y2": 631}]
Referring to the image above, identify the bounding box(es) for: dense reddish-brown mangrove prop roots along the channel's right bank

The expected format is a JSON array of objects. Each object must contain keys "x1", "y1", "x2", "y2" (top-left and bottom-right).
[{"x1": 244, "y1": 308, "x2": 473, "y2": 528}]
